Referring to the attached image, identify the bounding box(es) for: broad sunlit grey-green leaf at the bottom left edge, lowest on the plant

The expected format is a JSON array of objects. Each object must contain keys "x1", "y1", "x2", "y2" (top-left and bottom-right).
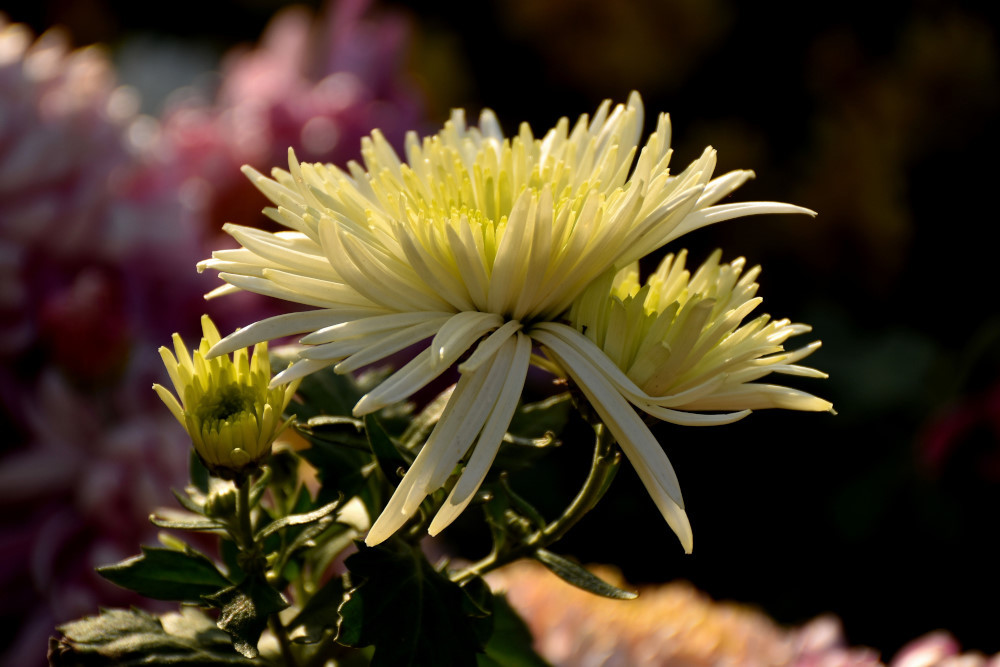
[{"x1": 49, "y1": 607, "x2": 262, "y2": 667}]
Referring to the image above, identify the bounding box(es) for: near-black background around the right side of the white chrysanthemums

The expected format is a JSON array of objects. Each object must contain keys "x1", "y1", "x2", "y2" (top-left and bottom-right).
[{"x1": 2, "y1": 0, "x2": 1000, "y2": 655}]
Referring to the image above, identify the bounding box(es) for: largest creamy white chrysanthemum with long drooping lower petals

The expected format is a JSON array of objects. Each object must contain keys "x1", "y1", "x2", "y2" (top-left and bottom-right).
[{"x1": 200, "y1": 94, "x2": 812, "y2": 549}]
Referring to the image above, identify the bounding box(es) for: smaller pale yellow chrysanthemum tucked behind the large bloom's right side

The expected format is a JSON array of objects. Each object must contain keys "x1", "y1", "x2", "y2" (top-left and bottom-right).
[{"x1": 560, "y1": 250, "x2": 833, "y2": 426}]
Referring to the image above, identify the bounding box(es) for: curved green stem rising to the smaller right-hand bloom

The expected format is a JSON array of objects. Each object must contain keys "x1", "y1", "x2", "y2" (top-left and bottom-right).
[{"x1": 451, "y1": 423, "x2": 621, "y2": 584}]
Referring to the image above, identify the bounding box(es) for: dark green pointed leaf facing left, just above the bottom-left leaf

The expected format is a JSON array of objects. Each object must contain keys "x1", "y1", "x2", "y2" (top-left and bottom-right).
[{"x1": 97, "y1": 547, "x2": 230, "y2": 604}]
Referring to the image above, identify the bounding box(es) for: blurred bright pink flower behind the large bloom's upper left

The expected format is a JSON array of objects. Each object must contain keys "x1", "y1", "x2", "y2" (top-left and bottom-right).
[{"x1": 154, "y1": 0, "x2": 423, "y2": 243}]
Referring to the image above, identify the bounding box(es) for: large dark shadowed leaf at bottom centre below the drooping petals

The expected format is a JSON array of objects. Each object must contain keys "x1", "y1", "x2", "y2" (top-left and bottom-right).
[{"x1": 337, "y1": 540, "x2": 482, "y2": 667}]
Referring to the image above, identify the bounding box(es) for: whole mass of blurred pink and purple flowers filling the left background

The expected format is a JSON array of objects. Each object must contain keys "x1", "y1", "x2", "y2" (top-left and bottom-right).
[{"x1": 0, "y1": 0, "x2": 421, "y2": 666}]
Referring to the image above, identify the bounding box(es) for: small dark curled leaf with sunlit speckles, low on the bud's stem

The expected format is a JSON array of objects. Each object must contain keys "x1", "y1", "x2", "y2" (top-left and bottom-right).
[{"x1": 205, "y1": 576, "x2": 288, "y2": 658}]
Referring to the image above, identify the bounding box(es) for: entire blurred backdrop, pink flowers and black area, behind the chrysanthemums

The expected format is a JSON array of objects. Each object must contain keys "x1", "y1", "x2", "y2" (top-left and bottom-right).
[{"x1": 0, "y1": 0, "x2": 1000, "y2": 664}]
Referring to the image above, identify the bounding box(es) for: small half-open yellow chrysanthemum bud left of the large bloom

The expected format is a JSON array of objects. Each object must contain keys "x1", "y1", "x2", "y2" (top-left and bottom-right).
[{"x1": 153, "y1": 315, "x2": 298, "y2": 479}]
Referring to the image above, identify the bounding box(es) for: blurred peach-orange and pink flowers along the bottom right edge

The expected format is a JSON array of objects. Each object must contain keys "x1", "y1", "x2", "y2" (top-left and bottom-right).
[{"x1": 488, "y1": 561, "x2": 1000, "y2": 667}]
